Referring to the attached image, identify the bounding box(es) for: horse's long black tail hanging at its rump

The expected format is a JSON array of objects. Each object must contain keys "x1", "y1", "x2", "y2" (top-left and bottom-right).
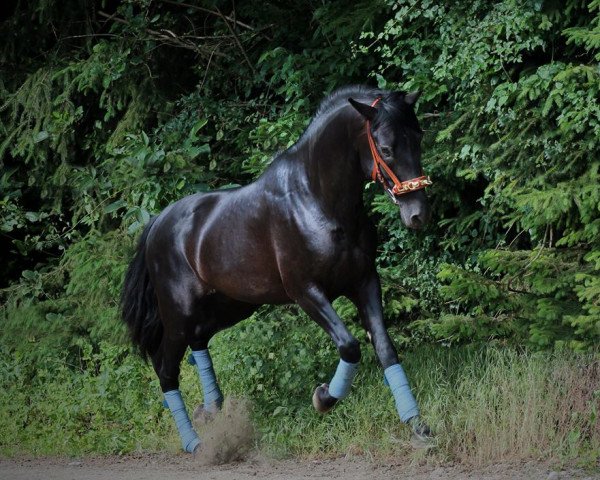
[{"x1": 121, "y1": 217, "x2": 163, "y2": 359}]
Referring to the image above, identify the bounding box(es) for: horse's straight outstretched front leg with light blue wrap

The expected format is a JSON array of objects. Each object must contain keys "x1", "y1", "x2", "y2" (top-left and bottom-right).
[{"x1": 352, "y1": 272, "x2": 431, "y2": 440}]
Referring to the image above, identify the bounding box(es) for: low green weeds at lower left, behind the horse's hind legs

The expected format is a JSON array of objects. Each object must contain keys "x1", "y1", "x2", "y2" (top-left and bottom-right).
[{"x1": 0, "y1": 340, "x2": 170, "y2": 455}]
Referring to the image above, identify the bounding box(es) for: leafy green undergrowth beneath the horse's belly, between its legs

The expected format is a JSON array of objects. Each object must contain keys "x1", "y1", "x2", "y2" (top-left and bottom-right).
[{"x1": 210, "y1": 308, "x2": 336, "y2": 415}]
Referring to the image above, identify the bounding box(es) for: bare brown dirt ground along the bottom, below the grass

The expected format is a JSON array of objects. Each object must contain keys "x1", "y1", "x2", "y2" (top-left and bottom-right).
[{"x1": 0, "y1": 454, "x2": 600, "y2": 480}]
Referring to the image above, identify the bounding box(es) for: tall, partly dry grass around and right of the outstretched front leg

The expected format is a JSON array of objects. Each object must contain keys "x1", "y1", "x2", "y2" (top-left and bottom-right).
[{"x1": 254, "y1": 347, "x2": 600, "y2": 465}]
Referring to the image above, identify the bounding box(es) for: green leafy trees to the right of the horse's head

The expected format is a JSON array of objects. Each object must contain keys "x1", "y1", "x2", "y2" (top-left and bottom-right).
[{"x1": 354, "y1": 1, "x2": 600, "y2": 349}]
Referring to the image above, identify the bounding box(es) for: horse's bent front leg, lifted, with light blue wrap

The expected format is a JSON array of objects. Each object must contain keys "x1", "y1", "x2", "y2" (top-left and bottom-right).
[{"x1": 296, "y1": 287, "x2": 360, "y2": 413}]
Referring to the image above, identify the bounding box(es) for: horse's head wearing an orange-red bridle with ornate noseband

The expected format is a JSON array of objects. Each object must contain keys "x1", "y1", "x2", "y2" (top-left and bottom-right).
[{"x1": 348, "y1": 92, "x2": 431, "y2": 229}]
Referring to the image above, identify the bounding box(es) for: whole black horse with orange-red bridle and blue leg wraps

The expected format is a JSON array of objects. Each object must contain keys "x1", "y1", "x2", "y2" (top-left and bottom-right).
[{"x1": 121, "y1": 86, "x2": 431, "y2": 452}]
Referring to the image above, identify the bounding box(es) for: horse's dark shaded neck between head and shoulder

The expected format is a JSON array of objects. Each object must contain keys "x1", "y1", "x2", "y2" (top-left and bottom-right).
[{"x1": 301, "y1": 109, "x2": 365, "y2": 218}]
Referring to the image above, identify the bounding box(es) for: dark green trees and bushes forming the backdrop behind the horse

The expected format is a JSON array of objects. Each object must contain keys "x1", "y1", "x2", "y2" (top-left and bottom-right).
[{"x1": 0, "y1": 0, "x2": 600, "y2": 462}]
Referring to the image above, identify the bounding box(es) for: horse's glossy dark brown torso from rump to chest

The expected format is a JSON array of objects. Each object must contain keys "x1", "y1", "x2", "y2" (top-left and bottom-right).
[{"x1": 144, "y1": 157, "x2": 374, "y2": 304}]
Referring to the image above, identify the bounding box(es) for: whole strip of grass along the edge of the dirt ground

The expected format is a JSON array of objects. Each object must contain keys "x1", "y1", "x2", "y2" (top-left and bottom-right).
[{"x1": 0, "y1": 336, "x2": 600, "y2": 466}]
